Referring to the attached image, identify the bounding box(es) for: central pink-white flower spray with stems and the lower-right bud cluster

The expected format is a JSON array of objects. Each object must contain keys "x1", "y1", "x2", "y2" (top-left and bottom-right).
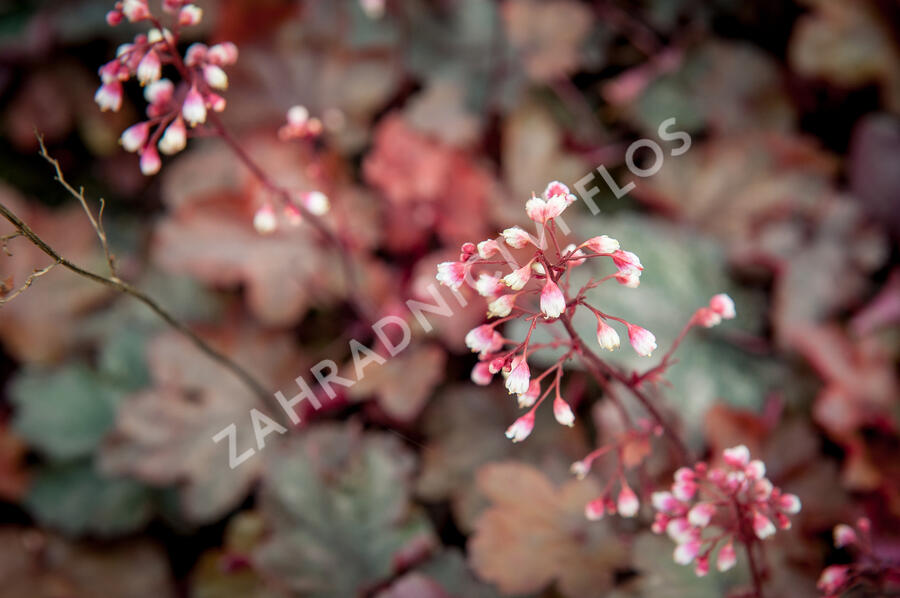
[{"x1": 437, "y1": 181, "x2": 800, "y2": 588}]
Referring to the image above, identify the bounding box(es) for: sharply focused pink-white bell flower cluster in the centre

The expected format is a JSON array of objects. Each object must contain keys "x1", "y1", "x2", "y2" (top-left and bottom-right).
[{"x1": 440, "y1": 183, "x2": 656, "y2": 446}]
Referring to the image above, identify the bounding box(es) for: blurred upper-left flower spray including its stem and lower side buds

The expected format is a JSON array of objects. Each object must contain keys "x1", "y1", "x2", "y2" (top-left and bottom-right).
[{"x1": 94, "y1": 0, "x2": 333, "y2": 240}]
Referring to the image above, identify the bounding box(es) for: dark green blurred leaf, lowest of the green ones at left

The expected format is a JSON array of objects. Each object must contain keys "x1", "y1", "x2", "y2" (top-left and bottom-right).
[{"x1": 25, "y1": 460, "x2": 154, "y2": 536}]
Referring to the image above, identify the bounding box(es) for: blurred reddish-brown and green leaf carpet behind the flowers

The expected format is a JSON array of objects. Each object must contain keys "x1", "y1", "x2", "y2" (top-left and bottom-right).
[{"x1": 0, "y1": 0, "x2": 900, "y2": 598}]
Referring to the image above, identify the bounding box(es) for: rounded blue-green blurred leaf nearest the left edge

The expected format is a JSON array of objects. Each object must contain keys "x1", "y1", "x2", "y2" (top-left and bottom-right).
[{"x1": 10, "y1": 364, "x2": 122, "y2": 460}]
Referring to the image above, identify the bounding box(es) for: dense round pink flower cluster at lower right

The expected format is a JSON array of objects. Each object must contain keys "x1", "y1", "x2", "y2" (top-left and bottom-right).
[{"x1": 652, "y1": 445, "x2": 800, "y2": 577}]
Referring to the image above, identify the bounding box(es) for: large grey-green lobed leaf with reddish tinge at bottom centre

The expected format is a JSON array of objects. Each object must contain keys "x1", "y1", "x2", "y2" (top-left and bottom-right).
[{"x1": 256, "y1": 426, "x2": 434, "y2": 598}]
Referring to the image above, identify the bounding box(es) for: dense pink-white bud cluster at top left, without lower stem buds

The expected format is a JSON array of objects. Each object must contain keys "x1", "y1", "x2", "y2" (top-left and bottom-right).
[{"x1": 94, "y1": 0, "x2": 238, "y2": 176}]
